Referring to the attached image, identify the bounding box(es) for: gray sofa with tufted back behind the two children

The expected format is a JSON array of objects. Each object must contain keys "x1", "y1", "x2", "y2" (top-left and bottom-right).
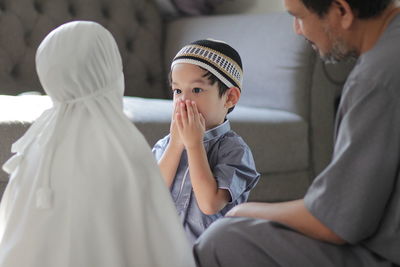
[{"x1": 0, "y1": 0, "x2": 351, "y2": 201}]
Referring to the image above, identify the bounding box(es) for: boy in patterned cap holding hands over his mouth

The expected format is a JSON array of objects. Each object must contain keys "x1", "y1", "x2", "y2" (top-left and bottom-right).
[{"x1": 153, "y1": 39, "x2": 259, "y2": 242}]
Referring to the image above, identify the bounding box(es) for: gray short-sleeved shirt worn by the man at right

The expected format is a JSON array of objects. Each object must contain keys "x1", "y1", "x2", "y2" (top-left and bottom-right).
[{"x1": 305, "y1": 15, "x2": 400, "y2": 264}]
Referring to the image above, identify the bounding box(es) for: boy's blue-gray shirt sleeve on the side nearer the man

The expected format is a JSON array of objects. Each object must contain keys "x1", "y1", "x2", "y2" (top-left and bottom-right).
[{"x1": 213, "y1": 139, "x2": 260, "y2": 202}]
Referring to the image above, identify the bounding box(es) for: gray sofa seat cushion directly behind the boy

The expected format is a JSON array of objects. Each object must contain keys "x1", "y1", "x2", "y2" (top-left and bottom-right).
[{"x1": 124, "y1": 97, "x2": 308, "y2": 173}]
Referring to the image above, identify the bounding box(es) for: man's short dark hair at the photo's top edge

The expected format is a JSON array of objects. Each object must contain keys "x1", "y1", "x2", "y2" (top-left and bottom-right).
[{"x1": 301, "y1": 0, "x2": 394, "y2": 19}]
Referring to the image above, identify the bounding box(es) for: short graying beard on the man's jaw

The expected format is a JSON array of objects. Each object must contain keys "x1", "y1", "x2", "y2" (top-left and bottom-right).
[{"x1": 313, "y1": 25, "x2": 359, "y2": 64}]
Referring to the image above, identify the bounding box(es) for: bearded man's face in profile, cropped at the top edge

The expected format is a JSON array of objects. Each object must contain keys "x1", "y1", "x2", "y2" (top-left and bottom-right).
[{"x1": 284, "y1": 0, "x2": 356, "y2": 63}]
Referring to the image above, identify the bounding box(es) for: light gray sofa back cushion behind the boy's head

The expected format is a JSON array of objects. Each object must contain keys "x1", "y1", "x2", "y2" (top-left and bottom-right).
[{"x1": 165, "y1": 13, "x2": 316, "y2": 118}]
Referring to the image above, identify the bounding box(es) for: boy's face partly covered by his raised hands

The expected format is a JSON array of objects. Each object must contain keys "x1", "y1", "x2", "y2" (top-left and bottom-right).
[{"x1": 171, "y1": 63, "x2": 231, "y2": 129}]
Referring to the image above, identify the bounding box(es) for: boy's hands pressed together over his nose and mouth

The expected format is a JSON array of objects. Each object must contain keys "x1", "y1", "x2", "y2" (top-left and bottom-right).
[{"x1": 176, "y1": 100, "x2": 206, "y2": 149}]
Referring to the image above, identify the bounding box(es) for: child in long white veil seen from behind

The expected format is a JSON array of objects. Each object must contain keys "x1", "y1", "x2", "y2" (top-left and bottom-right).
[{"x1": 0, "y1": 21, "x2": 194, "y2": 267}]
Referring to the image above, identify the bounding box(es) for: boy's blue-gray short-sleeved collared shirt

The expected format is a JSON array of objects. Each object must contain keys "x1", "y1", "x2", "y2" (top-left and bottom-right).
[{"x1": 153, "y1": 120, "x2": 260, "y2": 242}]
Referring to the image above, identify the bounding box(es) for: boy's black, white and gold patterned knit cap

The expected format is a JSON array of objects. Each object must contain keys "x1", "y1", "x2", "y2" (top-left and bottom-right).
[{"x1": 171, "y1": 39, "x2": 243, "y2": 90}]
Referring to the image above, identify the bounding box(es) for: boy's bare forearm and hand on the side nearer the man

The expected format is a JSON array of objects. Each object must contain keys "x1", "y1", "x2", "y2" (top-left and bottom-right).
[{"x1": 176, "y1": 100, "x2": 230, "y2": 215}]
